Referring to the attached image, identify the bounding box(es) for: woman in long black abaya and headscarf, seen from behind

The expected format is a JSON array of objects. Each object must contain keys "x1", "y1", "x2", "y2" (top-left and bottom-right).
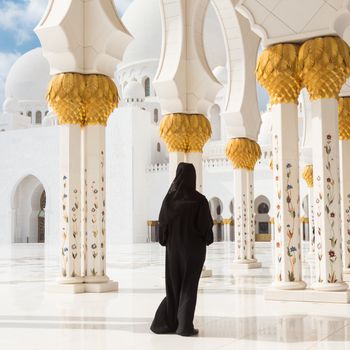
[{"x1": 151, "y1": 163, "x2": 213, "y2": 336}]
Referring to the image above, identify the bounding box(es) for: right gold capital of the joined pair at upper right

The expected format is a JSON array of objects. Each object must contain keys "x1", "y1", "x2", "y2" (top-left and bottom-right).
[{"x1": 298, "y1": 37, "x2": 350, "y2": 100}]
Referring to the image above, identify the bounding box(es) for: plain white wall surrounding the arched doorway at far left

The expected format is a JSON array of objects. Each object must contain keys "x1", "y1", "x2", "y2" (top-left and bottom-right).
[{"x1": 0, "y1": 127, "x2": 60, "y2": 245}]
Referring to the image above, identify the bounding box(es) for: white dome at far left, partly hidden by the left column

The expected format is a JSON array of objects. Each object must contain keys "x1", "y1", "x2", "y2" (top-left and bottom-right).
[{"x1": 5, "y1": 48, "x2": 50, "y2": 101}]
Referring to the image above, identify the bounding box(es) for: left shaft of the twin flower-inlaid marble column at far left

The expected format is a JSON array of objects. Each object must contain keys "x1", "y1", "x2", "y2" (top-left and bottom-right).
[{"x1": 58, "y1": 124, "x2": 84, "y2": 289}]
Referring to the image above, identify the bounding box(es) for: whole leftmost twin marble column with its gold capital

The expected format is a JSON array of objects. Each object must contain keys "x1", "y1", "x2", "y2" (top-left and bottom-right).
[{"x1": 48, "y1": 73, "x2": 118, "y2": 292}]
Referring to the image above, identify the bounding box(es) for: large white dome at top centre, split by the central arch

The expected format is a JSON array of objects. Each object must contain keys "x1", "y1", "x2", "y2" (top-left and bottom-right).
[{"x1": 122, "y1": 0, "x2": 226, "y2": 69}]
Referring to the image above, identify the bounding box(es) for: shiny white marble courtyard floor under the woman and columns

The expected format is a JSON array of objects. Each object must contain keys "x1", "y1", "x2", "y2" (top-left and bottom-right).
[{"x1": 0, "y1": 243, "x2": 350, "y2": 350}]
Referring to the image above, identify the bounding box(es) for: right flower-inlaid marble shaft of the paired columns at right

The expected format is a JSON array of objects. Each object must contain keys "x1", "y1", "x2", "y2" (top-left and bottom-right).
[{"x1": 312, "y1": 98, "x2": 348, "y2": 291}]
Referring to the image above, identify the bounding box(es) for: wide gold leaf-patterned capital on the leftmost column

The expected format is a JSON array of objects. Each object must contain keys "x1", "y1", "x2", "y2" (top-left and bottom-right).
[{"x1": 47, "y1": 73, "x2": 118, "y2": 126}]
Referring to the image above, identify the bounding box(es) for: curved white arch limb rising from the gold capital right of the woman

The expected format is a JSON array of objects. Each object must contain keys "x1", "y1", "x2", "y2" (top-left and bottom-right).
[{"x1": 212, "y1": 0, "x2": 261, "y2": 140}]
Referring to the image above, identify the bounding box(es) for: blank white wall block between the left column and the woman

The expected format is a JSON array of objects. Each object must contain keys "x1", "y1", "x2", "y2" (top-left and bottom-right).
[{"x1": 106, "y1": 106, "x2": 151, "y2": 243}]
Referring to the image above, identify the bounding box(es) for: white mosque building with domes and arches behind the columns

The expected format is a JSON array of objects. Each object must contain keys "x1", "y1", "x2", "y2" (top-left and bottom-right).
[{"x1": 0, "y1": 0, "x2": 309, "y2": 249}]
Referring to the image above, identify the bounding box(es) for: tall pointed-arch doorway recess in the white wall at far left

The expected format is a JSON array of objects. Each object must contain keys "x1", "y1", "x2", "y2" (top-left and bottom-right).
[{"x1": 12, "y1": 175, "x2": 46, "y2": 243}]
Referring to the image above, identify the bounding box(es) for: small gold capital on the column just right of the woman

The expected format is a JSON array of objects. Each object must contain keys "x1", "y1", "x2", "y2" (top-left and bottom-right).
[{"x1": 226, "y1": 138, "x2": 261, "y2": 171}]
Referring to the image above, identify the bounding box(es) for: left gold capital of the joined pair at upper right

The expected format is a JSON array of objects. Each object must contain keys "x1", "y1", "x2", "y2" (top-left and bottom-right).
[{"x1": 256, "y1": 44, "x2": 302, "y2": 104}]
